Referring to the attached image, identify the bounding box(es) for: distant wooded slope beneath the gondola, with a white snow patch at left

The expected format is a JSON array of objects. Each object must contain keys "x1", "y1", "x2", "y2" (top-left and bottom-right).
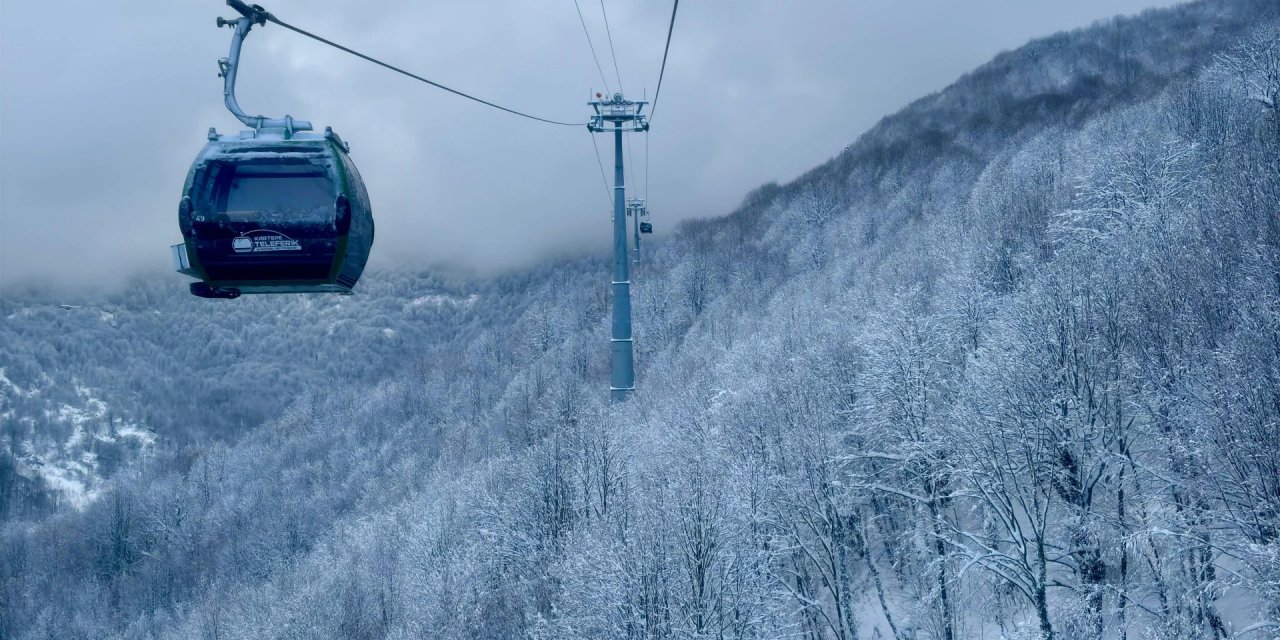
[{"x1": 0, "y1": 273, "x2": 511, "y2": 520}]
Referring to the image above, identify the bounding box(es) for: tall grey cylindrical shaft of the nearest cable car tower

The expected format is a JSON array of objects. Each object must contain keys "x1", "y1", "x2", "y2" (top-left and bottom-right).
[{"x1": 609, "y1": 122, "x2": 636, "y2": 402}]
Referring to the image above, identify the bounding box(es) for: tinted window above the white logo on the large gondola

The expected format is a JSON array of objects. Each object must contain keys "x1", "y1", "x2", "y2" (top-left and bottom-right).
[{"x1": 219, "y1": 172, "x2": 334, "y2": 224}]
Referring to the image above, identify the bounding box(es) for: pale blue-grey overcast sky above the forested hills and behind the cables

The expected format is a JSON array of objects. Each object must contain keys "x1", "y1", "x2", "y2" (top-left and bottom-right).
[{"x1": 0, "y1": 0, "x2": 1176, "y2": 287}]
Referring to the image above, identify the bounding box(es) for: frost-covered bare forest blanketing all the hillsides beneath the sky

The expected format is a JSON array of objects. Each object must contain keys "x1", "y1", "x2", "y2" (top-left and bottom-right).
[{"x1": 0, "y1": 0, "x2": 1280, "y2": 640}]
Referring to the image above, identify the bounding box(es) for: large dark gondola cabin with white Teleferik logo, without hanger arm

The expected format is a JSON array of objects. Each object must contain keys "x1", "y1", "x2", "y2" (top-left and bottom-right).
[{"x1": 173, "y1": 129, "x2": 374, "y2": 298}]
